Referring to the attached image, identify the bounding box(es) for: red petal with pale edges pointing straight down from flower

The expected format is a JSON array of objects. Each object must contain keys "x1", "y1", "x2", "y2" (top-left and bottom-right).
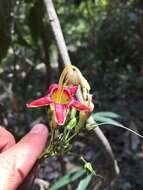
[{"x1": 52, "y1": 103, "x2": 69, "y2": 125}]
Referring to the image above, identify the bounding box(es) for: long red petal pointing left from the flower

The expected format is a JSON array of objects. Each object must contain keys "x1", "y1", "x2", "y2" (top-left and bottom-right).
[{"x1": 26, "y1": 96, "x2": 52, "y2": 108}]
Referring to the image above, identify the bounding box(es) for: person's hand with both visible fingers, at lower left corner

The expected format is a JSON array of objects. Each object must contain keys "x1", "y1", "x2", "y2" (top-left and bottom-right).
[{"x1": 0, "y1": 124, "x2": 48, "y2": 190}]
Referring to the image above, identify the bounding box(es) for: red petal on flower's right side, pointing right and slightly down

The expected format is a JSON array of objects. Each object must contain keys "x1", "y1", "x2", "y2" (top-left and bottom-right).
[{"x1": 70, "y1": 98, "x2": 91, "y2": 112}]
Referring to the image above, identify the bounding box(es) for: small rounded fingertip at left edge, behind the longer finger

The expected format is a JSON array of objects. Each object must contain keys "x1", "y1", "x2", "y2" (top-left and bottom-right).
[{"x1": 0, "y1": 127, "x2": 15, "y2": 152}]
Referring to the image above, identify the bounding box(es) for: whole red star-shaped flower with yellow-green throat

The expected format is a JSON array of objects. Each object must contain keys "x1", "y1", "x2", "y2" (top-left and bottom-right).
[{"x1": 26, "y1": 84, "x2": 91, "y2": 126}]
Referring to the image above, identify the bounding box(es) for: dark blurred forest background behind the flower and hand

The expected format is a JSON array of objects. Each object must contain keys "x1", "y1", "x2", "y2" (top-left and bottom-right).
[{"x1": 0, "y1": 0, "x2": 143, "y2": 190}]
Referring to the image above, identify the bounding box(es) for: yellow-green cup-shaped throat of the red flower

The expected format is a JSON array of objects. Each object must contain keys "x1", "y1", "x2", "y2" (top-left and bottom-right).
[{"x1": 51, "y1": 89, "x2": 70, "y2": 104}]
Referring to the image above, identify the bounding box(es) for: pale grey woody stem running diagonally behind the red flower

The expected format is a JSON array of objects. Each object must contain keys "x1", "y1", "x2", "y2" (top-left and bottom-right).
[{"x1": 44, "y1": 0, "x2": 119, "y2": 187}]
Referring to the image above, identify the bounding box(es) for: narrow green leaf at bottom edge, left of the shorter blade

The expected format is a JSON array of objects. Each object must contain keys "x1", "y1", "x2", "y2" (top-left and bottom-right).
[{"x1": 48, "y1": 169, "x2": 86, "y2": 190}]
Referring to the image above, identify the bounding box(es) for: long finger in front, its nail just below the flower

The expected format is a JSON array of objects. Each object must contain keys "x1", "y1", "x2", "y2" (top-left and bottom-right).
[{"x1": 0, "y1": 124, "x2": 48, "y2": 190}]
